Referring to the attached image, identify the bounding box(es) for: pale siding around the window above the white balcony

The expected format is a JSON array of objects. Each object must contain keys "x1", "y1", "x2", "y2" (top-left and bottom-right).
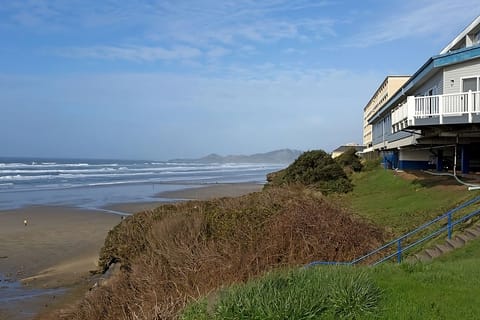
[{"x1": 443, "y1": 59, "x2": 480, "y2": 94}]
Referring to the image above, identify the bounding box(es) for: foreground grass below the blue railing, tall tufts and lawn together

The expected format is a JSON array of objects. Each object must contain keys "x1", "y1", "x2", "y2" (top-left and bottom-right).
[{"x1": 181, "y1": 241, "x2": 480, "y2": 320}]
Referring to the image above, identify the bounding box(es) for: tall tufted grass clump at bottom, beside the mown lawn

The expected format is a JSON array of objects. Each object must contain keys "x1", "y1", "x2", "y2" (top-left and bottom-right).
[{"x1": 181, "y1": 268, "x2": 380, "y2": 320}]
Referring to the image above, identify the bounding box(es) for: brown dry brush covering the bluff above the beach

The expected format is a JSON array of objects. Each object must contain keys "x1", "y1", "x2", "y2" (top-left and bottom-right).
[{"x1": 64, "y1": 187, "x2": 383, "y2": 319}]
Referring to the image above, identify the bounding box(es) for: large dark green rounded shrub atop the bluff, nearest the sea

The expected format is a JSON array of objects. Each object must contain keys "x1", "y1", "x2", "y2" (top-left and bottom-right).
[{"x1": 267, "y1": 150, "x2": 353, "y2": 194}]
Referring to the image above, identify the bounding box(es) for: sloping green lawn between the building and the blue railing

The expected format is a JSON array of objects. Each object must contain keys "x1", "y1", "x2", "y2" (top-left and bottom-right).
[{"x1": 340, "y1": 169, "x2": 479, "y2": 235}]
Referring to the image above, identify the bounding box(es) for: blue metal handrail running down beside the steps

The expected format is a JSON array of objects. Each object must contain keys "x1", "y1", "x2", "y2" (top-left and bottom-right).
[{"x1": 307, "y1": 196, "x2": 480, "y2": 267}]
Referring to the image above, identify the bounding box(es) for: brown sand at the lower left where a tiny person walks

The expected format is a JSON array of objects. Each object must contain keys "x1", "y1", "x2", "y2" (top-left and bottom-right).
[{"x1": 0, "y1": 206, "x2": 121, "y2": 319}]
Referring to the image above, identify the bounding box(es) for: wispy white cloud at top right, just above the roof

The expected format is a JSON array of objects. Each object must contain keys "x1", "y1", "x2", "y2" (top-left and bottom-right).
[{"x1": 346, "y1": 0, "x2": 479, "y2": 47}]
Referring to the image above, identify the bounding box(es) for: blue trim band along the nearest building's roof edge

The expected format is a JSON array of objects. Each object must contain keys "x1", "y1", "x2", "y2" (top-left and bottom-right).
[{"x1": 368, "y1": 45, "x2": 480, "y2": 124}]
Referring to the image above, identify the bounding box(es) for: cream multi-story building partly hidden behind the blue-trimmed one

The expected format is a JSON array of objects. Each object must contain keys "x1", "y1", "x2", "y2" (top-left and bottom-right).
[{"x1": 363, "y1": 76, "x2": 409, "y2": 152}]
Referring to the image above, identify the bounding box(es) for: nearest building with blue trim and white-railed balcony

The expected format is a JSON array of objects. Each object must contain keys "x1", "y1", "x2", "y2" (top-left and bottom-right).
[{"x1": 368, "y1": 16, "x2": 480, "y2": 173}]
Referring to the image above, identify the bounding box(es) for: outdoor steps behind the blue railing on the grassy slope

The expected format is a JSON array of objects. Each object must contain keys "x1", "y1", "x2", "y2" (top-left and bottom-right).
[{"x1": 407, "y1": 222, "x2": 480, "y2": 262}]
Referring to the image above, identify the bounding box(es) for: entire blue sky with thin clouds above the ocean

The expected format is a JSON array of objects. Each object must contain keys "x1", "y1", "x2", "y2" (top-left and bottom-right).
[{"x1": 0, "y1": 0, "x2": 480, "y2": 160}]
